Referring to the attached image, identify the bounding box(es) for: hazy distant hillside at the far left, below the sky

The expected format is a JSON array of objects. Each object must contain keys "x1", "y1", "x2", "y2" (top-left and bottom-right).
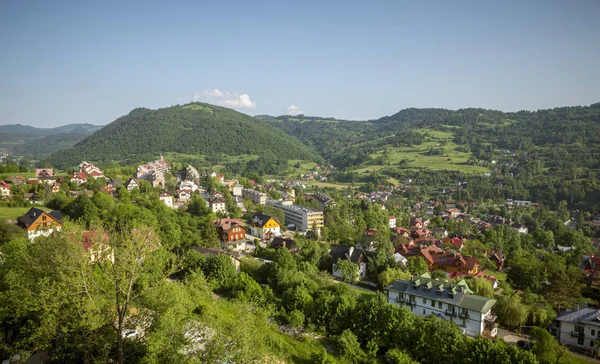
[{"x1": 0, "y1": 124, "x2": 102, "y2": 158}]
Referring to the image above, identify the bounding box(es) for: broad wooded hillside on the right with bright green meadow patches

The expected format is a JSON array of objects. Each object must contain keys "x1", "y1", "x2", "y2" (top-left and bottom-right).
[{"x1": 268, "y1": 103, "x2": 600, "y2": 208}]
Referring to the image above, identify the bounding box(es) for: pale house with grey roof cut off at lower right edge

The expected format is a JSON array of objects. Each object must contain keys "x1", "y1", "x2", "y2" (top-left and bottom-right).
[{"x1": 550, "y1": 307, "x2": 600, "y2": 351}]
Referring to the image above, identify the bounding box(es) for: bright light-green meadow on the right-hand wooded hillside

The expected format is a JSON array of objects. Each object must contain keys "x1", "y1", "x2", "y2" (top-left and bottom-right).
[{"x1": 357, "y1": 128, "x2": 489, "y2": 173}]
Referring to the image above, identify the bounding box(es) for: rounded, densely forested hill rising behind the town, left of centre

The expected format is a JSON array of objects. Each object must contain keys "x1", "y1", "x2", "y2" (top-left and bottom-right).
[{"x1": 50, "y1": 103, "x2": 320, "y2": 168}]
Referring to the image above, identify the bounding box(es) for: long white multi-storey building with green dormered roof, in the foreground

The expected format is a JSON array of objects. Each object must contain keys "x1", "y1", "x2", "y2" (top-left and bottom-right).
[{"x1": 385, "y1": 273, "x2": 497, "y2": 337}]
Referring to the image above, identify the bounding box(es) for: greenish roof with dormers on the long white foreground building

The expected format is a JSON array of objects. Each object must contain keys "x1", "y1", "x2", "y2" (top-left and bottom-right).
[{"x1": 385, "y1": 273, "x2": 496, "y2": 312}]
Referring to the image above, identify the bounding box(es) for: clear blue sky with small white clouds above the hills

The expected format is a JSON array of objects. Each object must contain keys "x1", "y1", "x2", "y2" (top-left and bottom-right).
[{"x1": 0, "y1": 0, "x2": 600, "y2": 127}]
